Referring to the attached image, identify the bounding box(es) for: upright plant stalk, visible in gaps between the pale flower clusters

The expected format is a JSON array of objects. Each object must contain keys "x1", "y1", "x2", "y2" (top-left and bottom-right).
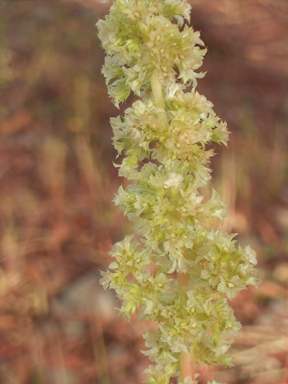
[{"x1": 150, "y1": 69, "x2": 195, "y2": 383}]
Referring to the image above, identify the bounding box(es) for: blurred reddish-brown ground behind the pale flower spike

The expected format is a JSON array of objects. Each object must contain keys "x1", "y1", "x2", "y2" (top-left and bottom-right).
[{"x1": 0, "y1": 0, "x2": 288, "y2": 384}]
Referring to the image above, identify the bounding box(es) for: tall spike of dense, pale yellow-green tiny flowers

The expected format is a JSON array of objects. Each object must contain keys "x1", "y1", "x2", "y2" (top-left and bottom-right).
[{"x1": 97, "y1": 0, "x2": 258, "y2": 384}]
